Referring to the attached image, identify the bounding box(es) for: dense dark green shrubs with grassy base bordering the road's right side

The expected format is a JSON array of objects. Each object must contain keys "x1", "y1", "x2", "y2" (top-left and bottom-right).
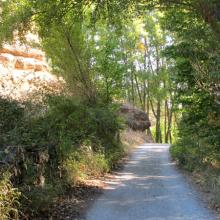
[{"x1": 171, "y1": 92, "x2": 220, "y2": 204}]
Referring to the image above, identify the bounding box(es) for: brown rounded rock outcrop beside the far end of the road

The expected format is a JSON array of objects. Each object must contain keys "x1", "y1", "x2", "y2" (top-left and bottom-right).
[{"x1": 120, "y1": 104, "x2": 151, "y2": 131}]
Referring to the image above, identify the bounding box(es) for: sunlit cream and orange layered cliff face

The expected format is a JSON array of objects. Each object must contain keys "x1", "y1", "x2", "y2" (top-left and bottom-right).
[{"x1": 0, "y1": 35, "x2": 63, "y2": 101}]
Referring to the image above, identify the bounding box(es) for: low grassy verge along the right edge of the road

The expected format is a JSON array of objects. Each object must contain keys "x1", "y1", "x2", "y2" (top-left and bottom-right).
[{"x1": 170, "y1": 144, "x2": 220, "y2": 213}]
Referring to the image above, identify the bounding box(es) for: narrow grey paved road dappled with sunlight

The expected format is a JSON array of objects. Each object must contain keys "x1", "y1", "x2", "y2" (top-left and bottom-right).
[{"x1": 86, "y1": 144, "x2": 218, "y2": 220}]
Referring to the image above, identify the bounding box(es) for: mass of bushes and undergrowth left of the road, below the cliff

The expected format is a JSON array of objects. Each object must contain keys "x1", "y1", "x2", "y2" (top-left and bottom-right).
[{"x1": 0, "y1": 96, "x2": 124, "y2": 219}]
